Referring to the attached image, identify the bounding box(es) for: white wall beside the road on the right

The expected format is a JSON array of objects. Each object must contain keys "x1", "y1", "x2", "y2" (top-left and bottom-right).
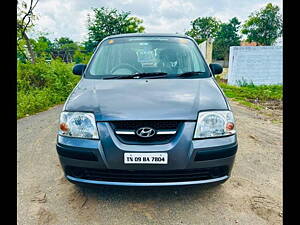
[{"x1": 227, "y1": 46, "x2": 283, "y2": 85}]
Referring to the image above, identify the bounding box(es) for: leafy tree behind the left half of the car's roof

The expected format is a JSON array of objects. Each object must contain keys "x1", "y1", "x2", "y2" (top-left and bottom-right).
[{"x1": 84, "y1": 7, "x2": 145, "y2": 51}]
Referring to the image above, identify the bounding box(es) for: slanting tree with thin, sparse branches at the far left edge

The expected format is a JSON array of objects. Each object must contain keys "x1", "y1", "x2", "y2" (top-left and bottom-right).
[{"x1": 17, "y1": 0, "x2": 39, "y2": 63}]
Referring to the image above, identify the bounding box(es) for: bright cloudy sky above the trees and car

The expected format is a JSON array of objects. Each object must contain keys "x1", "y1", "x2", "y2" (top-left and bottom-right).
[{"x1": 25, "y1": 0, "x2": 282, "y2": 42}]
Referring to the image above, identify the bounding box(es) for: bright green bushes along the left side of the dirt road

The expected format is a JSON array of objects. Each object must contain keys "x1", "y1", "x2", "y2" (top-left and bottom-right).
[{"x1": 17, "y1": 59, "x2": 80, "y2": 118}]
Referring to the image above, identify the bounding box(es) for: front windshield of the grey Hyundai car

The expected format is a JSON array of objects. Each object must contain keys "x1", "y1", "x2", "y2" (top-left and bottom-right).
[{"x1": 86, "y1": 37, "x2": 210, "y2": 78}]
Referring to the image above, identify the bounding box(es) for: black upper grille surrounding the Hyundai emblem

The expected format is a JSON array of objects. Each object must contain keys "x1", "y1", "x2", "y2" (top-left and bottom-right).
[{"x1": 110, "y1": 120, "x2": 183, "y2": 144}]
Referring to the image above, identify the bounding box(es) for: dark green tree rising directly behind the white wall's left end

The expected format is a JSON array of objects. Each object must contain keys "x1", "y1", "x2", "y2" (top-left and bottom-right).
[{"x1": 213, "y1": 17, "x2": 241, "y2": 67}]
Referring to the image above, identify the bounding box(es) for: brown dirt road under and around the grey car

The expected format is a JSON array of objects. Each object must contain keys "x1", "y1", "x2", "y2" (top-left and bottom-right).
[{"x1": 17, "y1": 102, "x2": 282, "y2": 225}]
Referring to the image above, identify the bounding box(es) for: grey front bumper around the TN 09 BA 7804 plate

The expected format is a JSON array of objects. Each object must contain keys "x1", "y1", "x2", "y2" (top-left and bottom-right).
[{"x1": 56, "y1": 122, "x2": 238, "y2": 186}]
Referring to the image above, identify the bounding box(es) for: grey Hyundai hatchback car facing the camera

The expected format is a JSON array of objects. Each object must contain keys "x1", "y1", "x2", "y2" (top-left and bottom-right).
[{"x1": 56, "y1": 34, "x2": 238, "y2": 186}]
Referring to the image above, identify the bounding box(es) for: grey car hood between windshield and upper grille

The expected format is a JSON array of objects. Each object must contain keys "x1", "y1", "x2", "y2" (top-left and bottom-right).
[{"x1": 64, "y1": 78, "x2": 228, "y2": 121}]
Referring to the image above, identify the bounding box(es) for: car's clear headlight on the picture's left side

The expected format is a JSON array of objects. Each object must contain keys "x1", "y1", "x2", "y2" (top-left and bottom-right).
[{"x1": 59, "y1": 112, "x2": 99, "y2": 139}]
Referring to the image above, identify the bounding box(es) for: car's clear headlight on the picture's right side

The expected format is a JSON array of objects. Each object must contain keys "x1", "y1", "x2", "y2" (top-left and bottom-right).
[{"x1": 194, "y1": 111, "x2": 235, "y2": 138}]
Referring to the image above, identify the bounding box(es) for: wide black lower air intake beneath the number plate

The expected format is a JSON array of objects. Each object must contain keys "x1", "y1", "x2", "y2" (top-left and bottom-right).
[{"x1": 65, "y1": 166, "x2": 229, "y2": 183}]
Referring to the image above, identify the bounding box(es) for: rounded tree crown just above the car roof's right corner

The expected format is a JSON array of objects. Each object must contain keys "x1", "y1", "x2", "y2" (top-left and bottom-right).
[{"x1": 186, "y1": 17, "x2": 220, "y2": 43}]
